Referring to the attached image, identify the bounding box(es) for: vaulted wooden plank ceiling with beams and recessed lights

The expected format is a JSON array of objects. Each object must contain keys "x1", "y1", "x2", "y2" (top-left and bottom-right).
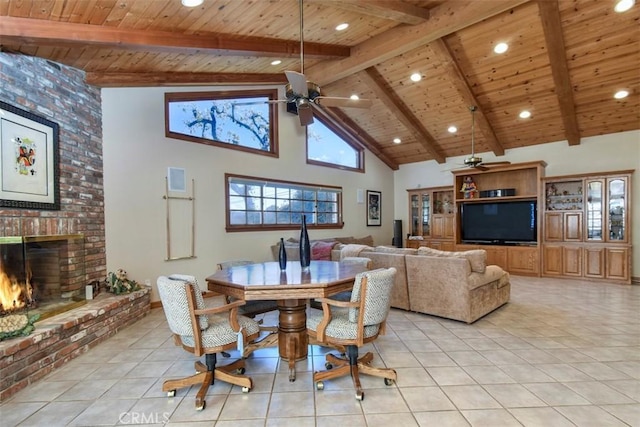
[{"x1": 0, "y1": 0, "x2": 640, "y2": 169}]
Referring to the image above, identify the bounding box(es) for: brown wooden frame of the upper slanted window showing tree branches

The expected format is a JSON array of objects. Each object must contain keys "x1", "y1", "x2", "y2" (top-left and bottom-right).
[{"x1": 164, "y1": 89, "x2": 279, "y2": 158}]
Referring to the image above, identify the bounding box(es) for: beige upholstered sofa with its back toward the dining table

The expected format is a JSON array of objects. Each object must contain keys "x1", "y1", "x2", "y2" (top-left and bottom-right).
[{"x1": 332, "y1": 245, "x2": 511, "y2": 323}]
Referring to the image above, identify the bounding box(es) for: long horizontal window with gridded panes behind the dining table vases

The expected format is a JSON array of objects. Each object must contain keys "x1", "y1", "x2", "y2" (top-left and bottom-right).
[{"x1": 225, "y1": 174, "x2": 343, "y2": 231}]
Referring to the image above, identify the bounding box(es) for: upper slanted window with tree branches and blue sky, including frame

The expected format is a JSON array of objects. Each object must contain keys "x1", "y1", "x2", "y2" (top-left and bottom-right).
[{"x1": 165, "y1": 90, "x2": 278, "y2": 157}]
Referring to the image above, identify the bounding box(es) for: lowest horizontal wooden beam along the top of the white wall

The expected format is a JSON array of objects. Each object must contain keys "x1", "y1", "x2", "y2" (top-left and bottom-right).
[{"x1": 85, "y1": 72, "x2": 287, "y2": 87}]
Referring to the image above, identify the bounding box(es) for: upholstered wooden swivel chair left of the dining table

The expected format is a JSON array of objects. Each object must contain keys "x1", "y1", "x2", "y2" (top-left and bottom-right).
[{"x1": 157, "y1": 274, "x2": 260, "y2": 410}]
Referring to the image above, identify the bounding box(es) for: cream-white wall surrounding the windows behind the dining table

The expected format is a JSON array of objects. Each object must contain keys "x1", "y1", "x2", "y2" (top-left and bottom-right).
[{"x1": 102, "y1": 87, "x2": 395, "y2": 300}]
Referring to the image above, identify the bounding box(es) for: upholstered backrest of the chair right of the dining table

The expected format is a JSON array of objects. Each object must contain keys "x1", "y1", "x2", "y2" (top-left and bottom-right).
[{"x1": 349, "y1": 267, "x2": 396, "y2": 326}]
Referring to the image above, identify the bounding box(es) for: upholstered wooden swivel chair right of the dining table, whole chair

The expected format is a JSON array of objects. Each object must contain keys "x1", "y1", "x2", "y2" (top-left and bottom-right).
[{"x1": 307, "y1": 267, "x2": 397, "y2": 400}]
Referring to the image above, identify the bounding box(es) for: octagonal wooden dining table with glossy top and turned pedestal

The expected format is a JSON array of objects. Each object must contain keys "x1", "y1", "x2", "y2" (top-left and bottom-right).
[{"x1": 206, "y1": 260, "x2": 367, "y2": 381}]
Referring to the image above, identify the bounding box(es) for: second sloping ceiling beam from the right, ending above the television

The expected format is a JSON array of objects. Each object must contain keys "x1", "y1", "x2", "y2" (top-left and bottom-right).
[{"x1": 429, "y1": 39, "x2": 504, "y2": 156}]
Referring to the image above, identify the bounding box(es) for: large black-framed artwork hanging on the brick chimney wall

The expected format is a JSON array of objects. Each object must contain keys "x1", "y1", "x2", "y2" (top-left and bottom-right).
[{"x1": 0, "y1": 101, "x2": 60, "y2": 210}]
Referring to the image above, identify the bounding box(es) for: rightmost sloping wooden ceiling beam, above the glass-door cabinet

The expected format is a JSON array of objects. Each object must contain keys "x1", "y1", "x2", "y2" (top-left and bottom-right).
[{"x1": 538, "y1": 0, "x2": 580, "y2": 145}]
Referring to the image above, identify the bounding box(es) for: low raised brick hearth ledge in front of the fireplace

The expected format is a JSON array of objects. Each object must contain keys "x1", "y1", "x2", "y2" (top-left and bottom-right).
[{"x1": 0, "y1": 287, "x2": 151, "y2": 402}]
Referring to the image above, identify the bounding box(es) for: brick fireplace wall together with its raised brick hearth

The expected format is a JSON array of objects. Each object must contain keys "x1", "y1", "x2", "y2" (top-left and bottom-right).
[{"x1": 0, "y1": 52, "x2": 116, "y2": 400}]
